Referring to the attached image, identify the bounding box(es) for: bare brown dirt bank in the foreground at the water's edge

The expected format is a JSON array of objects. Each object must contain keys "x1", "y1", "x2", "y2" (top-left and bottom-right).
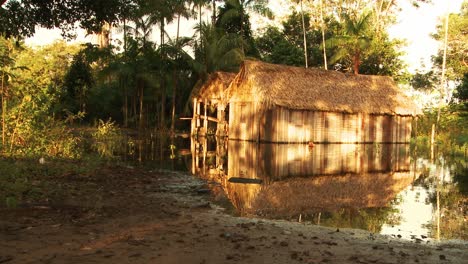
[{"x1": 0, "y1": 167, "x2": 468, "y2": 264}]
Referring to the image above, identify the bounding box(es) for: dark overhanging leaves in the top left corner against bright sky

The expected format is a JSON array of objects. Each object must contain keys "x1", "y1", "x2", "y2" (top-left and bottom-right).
[{"x1": 0, "y1": 0, "x2": 137, "y2": 37}]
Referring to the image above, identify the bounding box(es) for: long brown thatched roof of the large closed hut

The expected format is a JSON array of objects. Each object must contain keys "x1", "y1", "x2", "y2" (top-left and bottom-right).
[{"x1": 228, "y1": 60, "x2": 422, "y2": 115}]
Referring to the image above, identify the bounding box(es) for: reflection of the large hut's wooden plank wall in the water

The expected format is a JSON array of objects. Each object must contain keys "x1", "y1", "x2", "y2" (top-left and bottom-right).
[{"x1": 228, "y1": 141, "x2": 410, "y2": 181}]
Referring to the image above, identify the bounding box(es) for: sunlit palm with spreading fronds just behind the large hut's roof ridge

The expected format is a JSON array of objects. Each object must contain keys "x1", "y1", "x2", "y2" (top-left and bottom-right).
[{"x1": 326, "y1": 12, "x2": 371, "y2": 74}]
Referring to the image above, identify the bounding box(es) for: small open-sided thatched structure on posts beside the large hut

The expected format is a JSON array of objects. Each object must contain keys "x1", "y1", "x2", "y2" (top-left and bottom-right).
[{"x1": 192, "y1": 72, "x2": 235, "y2": 135}]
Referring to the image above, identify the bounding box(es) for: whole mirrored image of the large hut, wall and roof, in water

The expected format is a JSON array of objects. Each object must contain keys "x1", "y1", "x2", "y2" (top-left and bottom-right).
[{"x1": 223, "y1": 141, "x2": 414, "y2": 216}]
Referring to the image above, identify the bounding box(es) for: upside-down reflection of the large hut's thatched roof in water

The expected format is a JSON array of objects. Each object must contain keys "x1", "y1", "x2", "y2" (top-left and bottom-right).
[{"x1": 226, "y1": 172, "x2": 414, "y2": 216}]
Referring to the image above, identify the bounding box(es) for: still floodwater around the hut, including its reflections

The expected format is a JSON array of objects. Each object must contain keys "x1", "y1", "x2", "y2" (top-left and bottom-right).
[{"x1": 111, "y1": 134, "x2": 468, "y2": 242}]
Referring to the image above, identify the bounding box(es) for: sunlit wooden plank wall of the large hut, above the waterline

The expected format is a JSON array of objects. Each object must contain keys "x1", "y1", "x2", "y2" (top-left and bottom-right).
[{"x1": 229, "y1": 102, "x2": 412, "y2": 143}]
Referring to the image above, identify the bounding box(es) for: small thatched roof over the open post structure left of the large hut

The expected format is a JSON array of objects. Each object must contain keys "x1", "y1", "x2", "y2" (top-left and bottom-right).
[{"x1": 197, "y1": 72, "x2": 236, "y2": 101}]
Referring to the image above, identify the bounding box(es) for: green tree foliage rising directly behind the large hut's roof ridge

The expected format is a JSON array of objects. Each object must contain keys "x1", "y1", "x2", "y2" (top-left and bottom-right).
[{"x1": 256, "y1": 4, "x2": 405, "y2": 77}]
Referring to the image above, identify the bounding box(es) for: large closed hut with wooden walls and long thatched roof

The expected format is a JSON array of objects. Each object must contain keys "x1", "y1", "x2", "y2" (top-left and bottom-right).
[{"x1": 225, "y1": 60, "x2": 421, "y2": 143}]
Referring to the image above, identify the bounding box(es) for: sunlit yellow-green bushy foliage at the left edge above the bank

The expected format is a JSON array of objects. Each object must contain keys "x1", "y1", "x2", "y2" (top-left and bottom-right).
[{"x1": 1, "y1": 39, "x2": 79, "y2": 157}]
